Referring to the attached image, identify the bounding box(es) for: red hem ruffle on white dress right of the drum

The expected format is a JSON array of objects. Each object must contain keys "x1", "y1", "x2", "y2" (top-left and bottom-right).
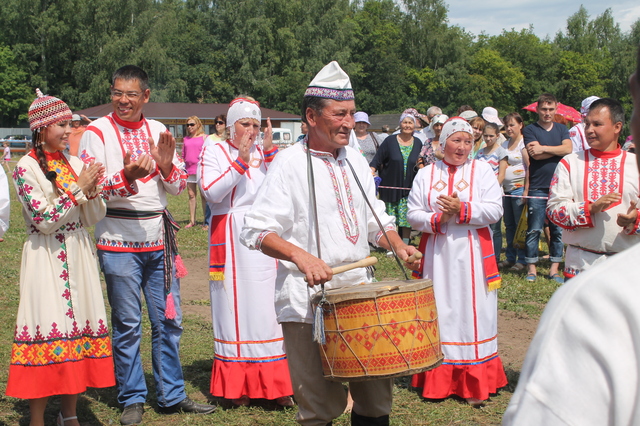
[{"x1": 411, "y1": 356, "x2": 507, "y2": 401}]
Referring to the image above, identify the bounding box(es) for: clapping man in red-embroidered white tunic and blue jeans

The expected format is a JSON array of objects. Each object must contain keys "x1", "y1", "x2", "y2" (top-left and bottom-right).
[{"x1": 80, "y1": 65, "x2": 215, "y2": 425}]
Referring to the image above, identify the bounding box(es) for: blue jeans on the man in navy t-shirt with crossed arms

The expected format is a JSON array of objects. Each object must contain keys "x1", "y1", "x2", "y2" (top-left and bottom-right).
[{"x1": 524, "y1": 189, "x2": 564, "y2": 263}]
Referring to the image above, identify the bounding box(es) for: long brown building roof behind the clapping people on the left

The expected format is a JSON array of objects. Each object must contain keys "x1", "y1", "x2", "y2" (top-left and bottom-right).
[{"x1": 74, "y1": 102, "x2": 300, "y2": 121}]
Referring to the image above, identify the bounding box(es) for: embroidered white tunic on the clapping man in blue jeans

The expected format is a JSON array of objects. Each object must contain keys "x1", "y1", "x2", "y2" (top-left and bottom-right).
[{"x1": 79, "y1": 113, "x2": 187, "y2": 252}]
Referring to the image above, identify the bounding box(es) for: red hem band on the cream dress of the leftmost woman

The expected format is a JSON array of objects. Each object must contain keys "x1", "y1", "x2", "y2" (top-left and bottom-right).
[{"x1": 6, "y1": 357, "x2": 116, "y2": 399}]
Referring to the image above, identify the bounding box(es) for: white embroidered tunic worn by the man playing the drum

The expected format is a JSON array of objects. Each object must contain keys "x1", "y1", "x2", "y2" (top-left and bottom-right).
[{"x1": 240, "y1": 139, "x2": 395, "y2": 324}]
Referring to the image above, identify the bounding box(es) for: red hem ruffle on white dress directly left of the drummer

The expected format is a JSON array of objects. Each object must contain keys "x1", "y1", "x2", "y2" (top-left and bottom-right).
[{"x1": 211, "y1": 359, "x2": 293, "y2": 400}]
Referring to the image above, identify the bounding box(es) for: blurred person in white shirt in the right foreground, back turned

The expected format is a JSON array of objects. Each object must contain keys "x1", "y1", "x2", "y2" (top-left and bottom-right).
[{"x1": 502, "y1": 45, "x2": 640, "y2": 426}]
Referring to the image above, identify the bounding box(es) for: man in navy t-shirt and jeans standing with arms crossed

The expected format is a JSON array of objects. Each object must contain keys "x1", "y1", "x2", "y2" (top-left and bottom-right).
[{"x1": 522, "y1": 93, "x2": 571, "y2": 282}]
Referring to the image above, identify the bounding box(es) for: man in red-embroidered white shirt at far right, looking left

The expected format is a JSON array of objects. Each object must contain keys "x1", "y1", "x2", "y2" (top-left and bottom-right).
[{"x1": 547, "y1": 98, "x2": 640, "y2": 279}]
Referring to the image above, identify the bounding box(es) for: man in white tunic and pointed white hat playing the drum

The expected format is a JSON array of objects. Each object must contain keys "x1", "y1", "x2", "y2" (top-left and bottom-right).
[{"x1": 241, "y1": 62, "x2": 418, "y2": 426}]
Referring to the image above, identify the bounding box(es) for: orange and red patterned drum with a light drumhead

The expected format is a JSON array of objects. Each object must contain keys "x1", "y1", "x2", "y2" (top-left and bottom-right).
[{"x1": 312, "y1": 279, "x2": 444, "y2": 381}]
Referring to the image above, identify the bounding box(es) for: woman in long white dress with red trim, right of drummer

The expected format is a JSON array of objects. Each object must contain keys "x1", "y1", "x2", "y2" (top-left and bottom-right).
[{"x1": 407, "y1": 117, "x2": 507, "y2": 406}]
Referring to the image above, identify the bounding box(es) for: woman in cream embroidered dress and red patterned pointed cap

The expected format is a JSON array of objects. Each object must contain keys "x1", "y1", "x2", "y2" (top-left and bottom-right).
[{"x1": 7, "y1": 90, "x2": 115, "y2": 426}]
